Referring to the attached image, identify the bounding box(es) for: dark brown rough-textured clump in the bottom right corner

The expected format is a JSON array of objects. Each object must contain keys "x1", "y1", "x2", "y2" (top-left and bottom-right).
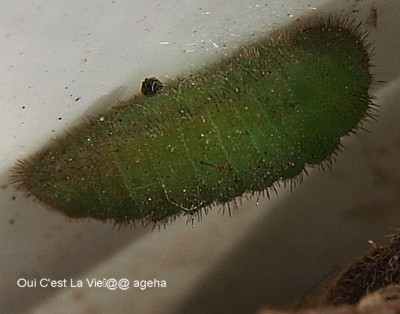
[{"x1": 258, "y1": 235, "x2": 400, "y2": 314}]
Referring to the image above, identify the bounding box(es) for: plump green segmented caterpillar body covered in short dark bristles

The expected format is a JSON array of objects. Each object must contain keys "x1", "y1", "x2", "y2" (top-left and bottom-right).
[{"x1": 23, "y1": 26, "x2": 371, "y2": 222}]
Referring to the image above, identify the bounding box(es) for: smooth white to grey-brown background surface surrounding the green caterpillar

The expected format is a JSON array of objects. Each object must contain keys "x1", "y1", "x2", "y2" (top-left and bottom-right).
[{"x1": 0, "y1": 0, "x2": 400, "y2": 313}]
